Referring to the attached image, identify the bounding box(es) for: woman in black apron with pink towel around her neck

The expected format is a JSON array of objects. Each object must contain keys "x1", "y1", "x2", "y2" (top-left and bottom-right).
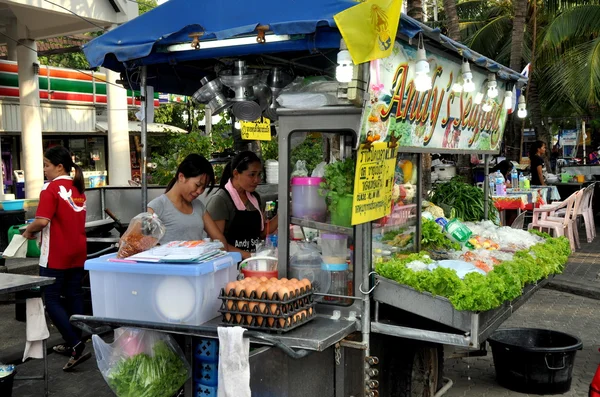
[{"x1": 207, "y1": 151, "x2": 277, "y2": 259}]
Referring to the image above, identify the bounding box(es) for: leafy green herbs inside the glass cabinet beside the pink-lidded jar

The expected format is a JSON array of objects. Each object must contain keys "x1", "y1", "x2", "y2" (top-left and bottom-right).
[{"x1": 319, "y1": 158, "x2": 355, "y2": 212}]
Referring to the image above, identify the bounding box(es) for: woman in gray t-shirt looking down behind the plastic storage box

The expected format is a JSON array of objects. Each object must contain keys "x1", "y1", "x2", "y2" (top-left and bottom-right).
[{"x1": 148, "y1": 154, "x2": 229, "y2": 250}]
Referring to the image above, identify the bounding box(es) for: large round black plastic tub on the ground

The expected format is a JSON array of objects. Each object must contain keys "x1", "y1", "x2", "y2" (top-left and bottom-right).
[{"x1": 488, "y1": 328, "x2": 583, "y2": 394}]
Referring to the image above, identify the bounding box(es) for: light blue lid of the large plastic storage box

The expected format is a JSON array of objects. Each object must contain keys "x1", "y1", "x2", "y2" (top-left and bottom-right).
[{"x1": 85, "y1": 252, "x2": 242, "y2": 276}]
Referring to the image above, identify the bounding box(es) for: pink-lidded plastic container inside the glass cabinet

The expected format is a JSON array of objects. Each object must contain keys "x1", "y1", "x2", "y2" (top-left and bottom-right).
[{"x1": 292, "y1": 177, "x2": 327, "y2": 222}]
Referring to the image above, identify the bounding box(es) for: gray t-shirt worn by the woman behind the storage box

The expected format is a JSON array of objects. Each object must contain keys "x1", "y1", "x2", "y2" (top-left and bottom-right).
[{"x1": 148, "y1": 194, "x2": 206, "y2": 244}]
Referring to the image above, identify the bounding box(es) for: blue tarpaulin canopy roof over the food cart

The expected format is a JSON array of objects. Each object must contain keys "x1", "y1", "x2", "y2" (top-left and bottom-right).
[{"x1": 83, "y1": 0, "x2": 527, "y2": 95}]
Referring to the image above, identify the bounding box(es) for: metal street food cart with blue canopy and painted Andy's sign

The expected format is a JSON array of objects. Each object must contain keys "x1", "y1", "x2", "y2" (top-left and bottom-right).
[{"x1": 67, "y1": 0, "x2": 572, "y2": 397}]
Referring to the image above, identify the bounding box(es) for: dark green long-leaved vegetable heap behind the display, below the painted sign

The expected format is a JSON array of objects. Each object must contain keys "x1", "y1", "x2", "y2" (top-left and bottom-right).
[{"x1": 431, "y1": 176, "x2": 498, "y2": 222}]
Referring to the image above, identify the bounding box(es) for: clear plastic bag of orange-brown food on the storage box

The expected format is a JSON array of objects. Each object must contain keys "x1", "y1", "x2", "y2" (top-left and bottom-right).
[{"x1": 117, "y1": 212, "x2": 165, "y2": 258}]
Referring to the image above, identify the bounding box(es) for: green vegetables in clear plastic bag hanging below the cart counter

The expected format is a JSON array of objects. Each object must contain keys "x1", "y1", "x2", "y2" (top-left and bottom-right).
[{"x1": 107, "y1": 341, "x2": 189, "y2": 397}]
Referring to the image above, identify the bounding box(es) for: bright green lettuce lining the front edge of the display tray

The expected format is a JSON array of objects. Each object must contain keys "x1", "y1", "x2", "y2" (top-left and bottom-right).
[{"x1": 375, "y1": 237, "x2": 571, "y2": 312}]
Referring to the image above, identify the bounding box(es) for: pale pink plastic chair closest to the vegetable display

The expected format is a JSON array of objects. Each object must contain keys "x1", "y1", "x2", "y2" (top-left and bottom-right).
[{"x1": 527, "y1": 192, "x2": 577, "y2": 251}]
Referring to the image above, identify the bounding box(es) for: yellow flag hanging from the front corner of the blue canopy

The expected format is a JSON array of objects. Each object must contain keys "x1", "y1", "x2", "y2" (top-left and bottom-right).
[{"x1": 333, "y1": 0, "x2": 402, "y2": 65}]
